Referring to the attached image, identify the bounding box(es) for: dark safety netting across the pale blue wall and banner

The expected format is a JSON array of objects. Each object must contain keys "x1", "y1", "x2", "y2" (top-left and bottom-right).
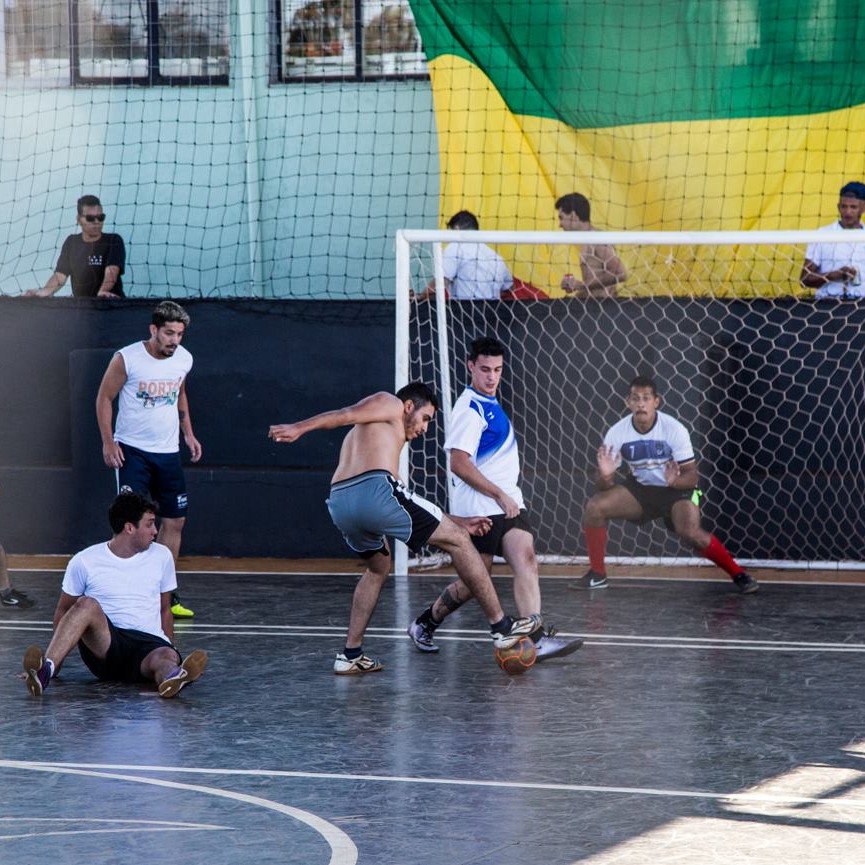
[{"x1": 0, "y1": 0, "x2": 865, "y2": 300}]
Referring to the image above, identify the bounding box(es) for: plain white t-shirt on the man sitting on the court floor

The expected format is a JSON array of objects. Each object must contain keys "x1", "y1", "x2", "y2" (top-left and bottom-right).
[{"x1": 63, "y1": 541, "x2": 177, "y2": 640}]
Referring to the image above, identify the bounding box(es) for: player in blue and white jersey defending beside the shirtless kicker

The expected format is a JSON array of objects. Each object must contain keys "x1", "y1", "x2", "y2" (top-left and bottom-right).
[{"x1": 408, "y1": 337, "x2": 582, "y2": 661}]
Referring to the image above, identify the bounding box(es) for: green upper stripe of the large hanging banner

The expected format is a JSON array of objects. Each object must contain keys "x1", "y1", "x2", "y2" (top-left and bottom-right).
[{"x1": 411, "y1": 0, "x2": 865, "y2": 129}]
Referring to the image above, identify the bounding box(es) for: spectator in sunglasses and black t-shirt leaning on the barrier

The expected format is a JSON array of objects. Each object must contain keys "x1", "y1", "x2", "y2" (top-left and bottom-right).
[{"x1": 27, "y1": 195, "x2": 126, "y2": 298}]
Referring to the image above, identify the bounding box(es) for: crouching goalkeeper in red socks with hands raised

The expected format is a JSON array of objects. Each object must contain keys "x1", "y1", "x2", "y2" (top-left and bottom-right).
[{"x1": 571, "y1": 376, "x2": 759, "y2": 594}]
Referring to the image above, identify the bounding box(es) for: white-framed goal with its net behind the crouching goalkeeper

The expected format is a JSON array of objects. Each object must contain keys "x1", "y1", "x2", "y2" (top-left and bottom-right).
[{"x1": 396, "y1": 231, "x2": 865, "y2": 567}]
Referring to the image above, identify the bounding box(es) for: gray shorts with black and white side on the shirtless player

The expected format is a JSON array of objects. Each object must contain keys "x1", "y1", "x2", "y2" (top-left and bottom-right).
[{"x1": 327, "y1": 470, "x2": 442, "y2": 558}]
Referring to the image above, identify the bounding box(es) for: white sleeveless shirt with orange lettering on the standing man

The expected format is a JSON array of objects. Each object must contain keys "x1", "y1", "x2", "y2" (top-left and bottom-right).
[{"x1": 114, "y1": 342, "x2": 192, "y2": 454}]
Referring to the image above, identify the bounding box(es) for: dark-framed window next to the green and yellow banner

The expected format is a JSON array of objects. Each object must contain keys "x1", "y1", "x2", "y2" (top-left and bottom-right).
[{"x1": 278, "y1": 0, "x2": 427, "y2": 81}]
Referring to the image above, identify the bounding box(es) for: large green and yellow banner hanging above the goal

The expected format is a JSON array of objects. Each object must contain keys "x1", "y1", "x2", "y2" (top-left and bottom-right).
[{"x1": 411, "y1": 0, "x2": 865, "y2": 296}]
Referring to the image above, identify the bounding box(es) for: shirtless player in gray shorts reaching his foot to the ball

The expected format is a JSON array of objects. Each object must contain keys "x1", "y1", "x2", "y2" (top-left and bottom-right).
[{"x1": 269, "y1": 382, "x2": 541, "y2": 675}]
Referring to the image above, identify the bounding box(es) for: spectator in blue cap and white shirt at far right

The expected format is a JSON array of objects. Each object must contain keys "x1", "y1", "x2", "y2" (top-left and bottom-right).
[{"x1": 799, "y1": 180, "x2": 865, "y2": 300}]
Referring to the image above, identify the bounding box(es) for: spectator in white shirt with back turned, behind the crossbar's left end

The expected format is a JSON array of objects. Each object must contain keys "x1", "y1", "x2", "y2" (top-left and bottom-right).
[{"x1": 417, "y1": 210, "x2": 514, "y2": 300}]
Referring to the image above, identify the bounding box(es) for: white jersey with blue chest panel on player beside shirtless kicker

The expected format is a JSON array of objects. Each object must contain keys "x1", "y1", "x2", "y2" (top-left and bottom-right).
[{"x1": 445, "y1": 387, "x2": 525, "y2": 517}]
